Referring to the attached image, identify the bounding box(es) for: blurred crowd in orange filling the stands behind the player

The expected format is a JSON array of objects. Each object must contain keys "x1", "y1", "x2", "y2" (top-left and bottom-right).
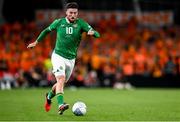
[{"x1": 0, "y1": 16, "x2": 180, "y2": 89}]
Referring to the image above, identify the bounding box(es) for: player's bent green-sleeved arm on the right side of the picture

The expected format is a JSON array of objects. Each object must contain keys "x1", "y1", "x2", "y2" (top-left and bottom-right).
[{"x1": 81, "y1": 20, "x2": 100, "y2": 38}]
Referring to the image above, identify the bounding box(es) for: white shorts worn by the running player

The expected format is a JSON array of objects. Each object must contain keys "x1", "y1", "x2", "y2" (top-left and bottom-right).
[{"x1": 51, "y1": 52, "x2": 75, "y2": 82}]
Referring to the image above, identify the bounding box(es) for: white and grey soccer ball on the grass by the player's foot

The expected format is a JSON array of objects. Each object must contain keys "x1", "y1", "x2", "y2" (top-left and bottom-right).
[{"x1": 72, "y1": 101, "x2": 87, "y2": 116}]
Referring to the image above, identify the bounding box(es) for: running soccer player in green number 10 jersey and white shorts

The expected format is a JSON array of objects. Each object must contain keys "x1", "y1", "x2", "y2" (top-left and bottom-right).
[{"x1": 27, "y1": 2, "x2": 100, "y2": 115}]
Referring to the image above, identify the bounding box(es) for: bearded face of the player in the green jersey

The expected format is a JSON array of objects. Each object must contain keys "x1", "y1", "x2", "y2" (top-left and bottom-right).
[{"x1": 66, "y1": 8, "x2": 78, "y2": 22}]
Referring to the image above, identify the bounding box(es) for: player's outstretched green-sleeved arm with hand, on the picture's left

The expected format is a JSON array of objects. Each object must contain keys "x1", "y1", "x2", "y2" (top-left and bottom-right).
[{"x1": 27, "y1": 20, "x2": 58, "y2": 48}]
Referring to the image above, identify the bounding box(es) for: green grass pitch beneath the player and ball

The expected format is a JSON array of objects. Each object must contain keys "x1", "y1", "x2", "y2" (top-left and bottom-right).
[{"x1": 0, "y1": 88, "x2": 180, "y2": 121}]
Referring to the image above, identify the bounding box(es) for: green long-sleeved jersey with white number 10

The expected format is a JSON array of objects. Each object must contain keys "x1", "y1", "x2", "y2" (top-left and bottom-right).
[{"x1": 37, "y1": 18, "x2": 100, "y2": 59}]
